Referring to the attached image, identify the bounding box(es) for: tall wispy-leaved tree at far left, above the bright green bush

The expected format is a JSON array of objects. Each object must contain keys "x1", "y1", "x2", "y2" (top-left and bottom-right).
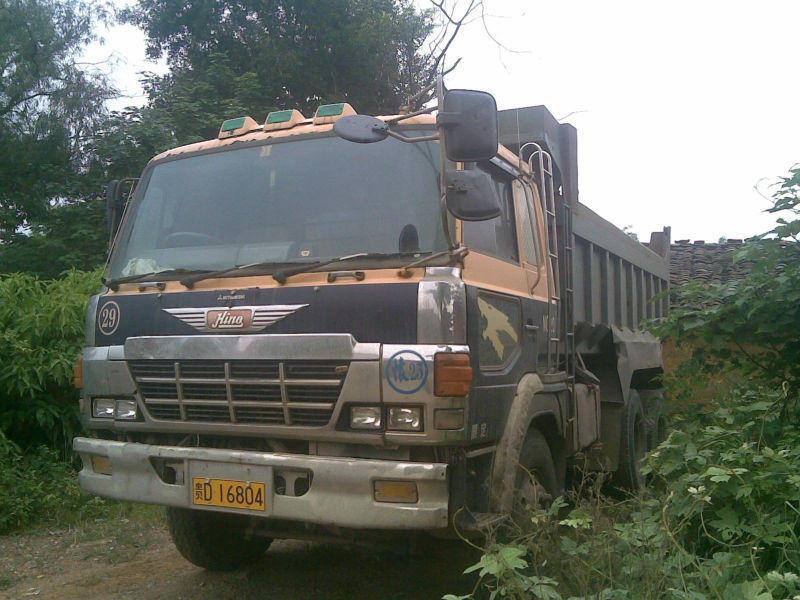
[{"x1": 0, "y1": 0, "x2": 114, "y2": 276}]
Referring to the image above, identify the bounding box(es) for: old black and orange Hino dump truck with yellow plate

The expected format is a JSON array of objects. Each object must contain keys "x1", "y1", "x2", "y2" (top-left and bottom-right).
[{"x1": 74, "y1": 82, "x2": 669, "y2": 570}]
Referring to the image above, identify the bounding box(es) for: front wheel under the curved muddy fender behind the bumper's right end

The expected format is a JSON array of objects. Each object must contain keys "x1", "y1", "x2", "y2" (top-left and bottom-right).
[{"x1": 511, "y1": 428, "x2": 562, "y2": 532}]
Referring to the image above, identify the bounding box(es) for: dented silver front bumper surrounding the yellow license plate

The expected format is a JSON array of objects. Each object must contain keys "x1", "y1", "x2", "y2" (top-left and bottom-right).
[{"x1": 73, "y1": 438, "x2": 448, "y2": 530}]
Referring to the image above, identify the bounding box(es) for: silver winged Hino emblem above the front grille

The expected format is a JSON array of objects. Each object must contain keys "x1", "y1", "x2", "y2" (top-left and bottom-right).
[{"x1": 162, "y1": 304, "x2": 308, "y2": 333}]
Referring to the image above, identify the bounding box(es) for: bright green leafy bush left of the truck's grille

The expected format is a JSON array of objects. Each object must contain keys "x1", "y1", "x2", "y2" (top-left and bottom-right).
[{"x1": 0, "y1": 271, "x2": 100, "y2": 453}]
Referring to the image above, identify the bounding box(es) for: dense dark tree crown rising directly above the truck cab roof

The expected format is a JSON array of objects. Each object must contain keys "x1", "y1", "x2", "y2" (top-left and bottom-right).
[{"x1": 124, "y1": 0, "x2": 432, "y2": 117}]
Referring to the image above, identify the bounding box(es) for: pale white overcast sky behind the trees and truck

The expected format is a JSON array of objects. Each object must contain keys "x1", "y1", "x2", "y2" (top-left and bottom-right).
[{"x1": 86, "y1": 0, "x2": 800, "y2": 242}]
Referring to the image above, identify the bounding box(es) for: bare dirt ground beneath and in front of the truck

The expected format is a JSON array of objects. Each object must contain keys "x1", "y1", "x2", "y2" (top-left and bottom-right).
[{"x1": 0, "y1": 518, "x2": 477, "y2": 600}]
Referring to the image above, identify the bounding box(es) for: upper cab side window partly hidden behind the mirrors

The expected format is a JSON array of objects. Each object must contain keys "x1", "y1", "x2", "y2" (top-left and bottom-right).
[{"x1": 463, "y1": 163, "x2": 519, "y2": 263}]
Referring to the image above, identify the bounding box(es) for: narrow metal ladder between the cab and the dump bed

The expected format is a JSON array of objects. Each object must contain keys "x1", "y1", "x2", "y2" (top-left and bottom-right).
[{"x1": 520, "y1": 147, "x2": 575, "y2": 390}]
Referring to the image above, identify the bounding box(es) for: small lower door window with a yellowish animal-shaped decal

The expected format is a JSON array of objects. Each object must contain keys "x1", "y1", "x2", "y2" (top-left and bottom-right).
[{"x1": 478, "y1": 292, "x2": 522, "y2": 369}]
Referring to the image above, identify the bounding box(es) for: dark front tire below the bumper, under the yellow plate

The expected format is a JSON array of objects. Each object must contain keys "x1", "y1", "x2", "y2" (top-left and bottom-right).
[{"x1": 167, "y1": 508, "x2": 272, "y2": 571}]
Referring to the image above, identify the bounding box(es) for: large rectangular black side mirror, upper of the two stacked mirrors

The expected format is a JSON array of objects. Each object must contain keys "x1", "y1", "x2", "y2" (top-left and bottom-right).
[{"x1": 436, "y1": 90, "x2": 498, "y2": 162}]
